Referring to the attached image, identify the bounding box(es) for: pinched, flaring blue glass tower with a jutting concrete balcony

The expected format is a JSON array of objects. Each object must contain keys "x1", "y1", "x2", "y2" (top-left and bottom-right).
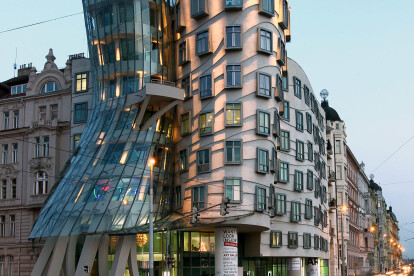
[{"x1": 30, "y1": 0, "x2": 178, "y2": 238}]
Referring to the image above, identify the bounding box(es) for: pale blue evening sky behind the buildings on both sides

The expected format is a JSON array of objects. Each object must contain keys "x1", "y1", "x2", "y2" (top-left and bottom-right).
[{"x1": 0, "y1": 0, "x2": 414, "y2": 258}]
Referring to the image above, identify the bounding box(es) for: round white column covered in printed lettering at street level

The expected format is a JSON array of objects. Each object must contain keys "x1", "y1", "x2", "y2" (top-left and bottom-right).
[{"x1": 215, "y1": 227, "x2": 238, "y2": 276}]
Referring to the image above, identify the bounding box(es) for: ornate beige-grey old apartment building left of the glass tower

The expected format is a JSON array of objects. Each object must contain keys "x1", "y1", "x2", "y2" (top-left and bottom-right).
[{"x1": 0, "y1": 50, "x2": 91, "y2": 275}]
